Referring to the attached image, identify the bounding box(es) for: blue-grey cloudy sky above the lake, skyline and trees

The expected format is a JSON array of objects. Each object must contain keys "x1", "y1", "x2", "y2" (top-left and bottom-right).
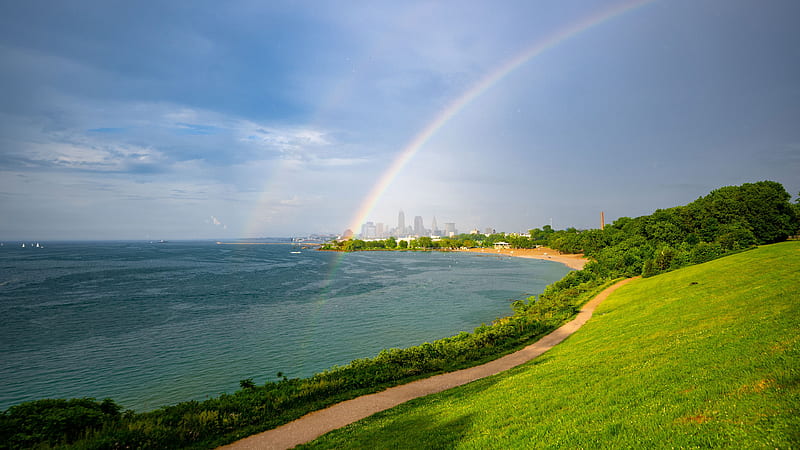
[{"x1": 0, "y1": 0, "x2": 800, "y2": 240}]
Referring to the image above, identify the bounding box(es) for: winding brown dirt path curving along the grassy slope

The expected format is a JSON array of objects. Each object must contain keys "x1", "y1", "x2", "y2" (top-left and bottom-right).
[{"x1": 221, "y1": 278, "x2": 634, "y2": 449}]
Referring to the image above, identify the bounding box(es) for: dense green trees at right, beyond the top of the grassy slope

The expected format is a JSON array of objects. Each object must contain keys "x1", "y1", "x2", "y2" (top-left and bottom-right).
[{"x1": 548, "y1": 181, "x2": 800, "y2": 277}]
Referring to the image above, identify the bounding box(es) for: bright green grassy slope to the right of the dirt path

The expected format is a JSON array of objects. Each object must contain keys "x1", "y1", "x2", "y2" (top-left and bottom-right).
[{"x1": 302, "y1": 242, "x2": 800, "y2": 448}]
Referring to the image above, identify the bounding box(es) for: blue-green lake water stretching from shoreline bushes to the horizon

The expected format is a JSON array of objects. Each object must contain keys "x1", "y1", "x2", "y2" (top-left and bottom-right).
[{"x1": 0, "y1": 242, "x2": 568, "y2": 410}]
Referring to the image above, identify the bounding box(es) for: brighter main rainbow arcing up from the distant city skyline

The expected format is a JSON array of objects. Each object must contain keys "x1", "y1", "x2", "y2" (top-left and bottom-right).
[{"x1": 349, "y1": 0, "x2": 655, "y2": 233}]
